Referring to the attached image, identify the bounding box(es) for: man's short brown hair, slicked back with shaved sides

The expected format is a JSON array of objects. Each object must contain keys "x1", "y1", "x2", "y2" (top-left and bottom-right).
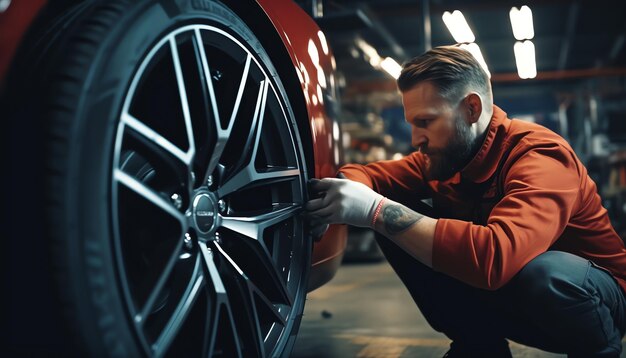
[{"x1": 398, "y1": 46, "x2": 493, "y2": 102}]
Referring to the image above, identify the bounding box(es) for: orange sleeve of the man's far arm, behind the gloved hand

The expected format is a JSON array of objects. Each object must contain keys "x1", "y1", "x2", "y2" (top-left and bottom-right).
[{"x1": 339, "y1": 153, "x2": 427, "y2": 201}]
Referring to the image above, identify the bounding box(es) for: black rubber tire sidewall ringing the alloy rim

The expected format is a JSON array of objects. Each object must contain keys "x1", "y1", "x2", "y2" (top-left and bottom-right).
[{"x1": 65, "y1": 0, "x2": 310, "y2": 356}]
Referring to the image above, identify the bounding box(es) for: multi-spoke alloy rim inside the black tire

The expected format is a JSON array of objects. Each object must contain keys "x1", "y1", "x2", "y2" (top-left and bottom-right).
[{"x1": 111, "y1": 24, "x2": 306, "y2": 356}]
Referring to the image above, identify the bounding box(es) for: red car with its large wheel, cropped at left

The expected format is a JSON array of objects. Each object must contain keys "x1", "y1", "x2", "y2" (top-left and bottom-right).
[{"x1": 0, "y1": 0, "x2": 346, "y2": 357}]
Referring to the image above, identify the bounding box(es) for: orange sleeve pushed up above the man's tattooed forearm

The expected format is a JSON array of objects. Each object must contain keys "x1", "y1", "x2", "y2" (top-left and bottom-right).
[{"x1": 433, "y1": 144, "x2": 580, "y2": 290}]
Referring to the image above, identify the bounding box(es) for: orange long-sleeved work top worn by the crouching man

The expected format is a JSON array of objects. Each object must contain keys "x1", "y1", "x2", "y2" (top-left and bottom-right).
[{"x1": 340, "y1": 106, "x2": 626, "y2": 292}]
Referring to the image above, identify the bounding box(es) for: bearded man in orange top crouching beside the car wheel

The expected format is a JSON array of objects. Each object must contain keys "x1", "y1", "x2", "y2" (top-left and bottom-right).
[{"x1": 306, "y1": 47, "x2": 626, "y2": 357}]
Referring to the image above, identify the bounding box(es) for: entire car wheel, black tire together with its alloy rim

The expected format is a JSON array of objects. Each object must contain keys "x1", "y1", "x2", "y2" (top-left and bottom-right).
[{"x1": 6, "y1": 0, "x2": 311, "y2": 357}]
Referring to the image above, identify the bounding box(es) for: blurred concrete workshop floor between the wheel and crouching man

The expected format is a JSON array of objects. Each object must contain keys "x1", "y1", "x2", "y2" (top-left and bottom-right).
[{"x1": 291, "y1": 262, "x2": 626, "y2": 358}]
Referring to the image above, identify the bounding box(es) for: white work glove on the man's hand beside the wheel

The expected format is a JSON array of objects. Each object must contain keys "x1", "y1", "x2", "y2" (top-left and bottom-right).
[{"x1": 305, "y1": 178, "x2": 384, "y2": 228}]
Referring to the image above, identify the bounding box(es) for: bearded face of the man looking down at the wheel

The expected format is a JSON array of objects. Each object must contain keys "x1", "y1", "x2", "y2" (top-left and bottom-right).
[{"x1": 402, "y1": 82, "x2": 475, "y2": 181}]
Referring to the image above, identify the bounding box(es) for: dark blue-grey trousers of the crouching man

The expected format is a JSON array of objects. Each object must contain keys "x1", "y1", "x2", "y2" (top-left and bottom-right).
[{"x1": 377, "y1": 237, "x2": 626, "y2": 357}]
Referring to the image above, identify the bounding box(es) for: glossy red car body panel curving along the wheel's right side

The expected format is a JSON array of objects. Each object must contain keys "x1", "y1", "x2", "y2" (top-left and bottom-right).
[{"x1": 257, "y1": 0, "x2": 347, "y2": 290}]
